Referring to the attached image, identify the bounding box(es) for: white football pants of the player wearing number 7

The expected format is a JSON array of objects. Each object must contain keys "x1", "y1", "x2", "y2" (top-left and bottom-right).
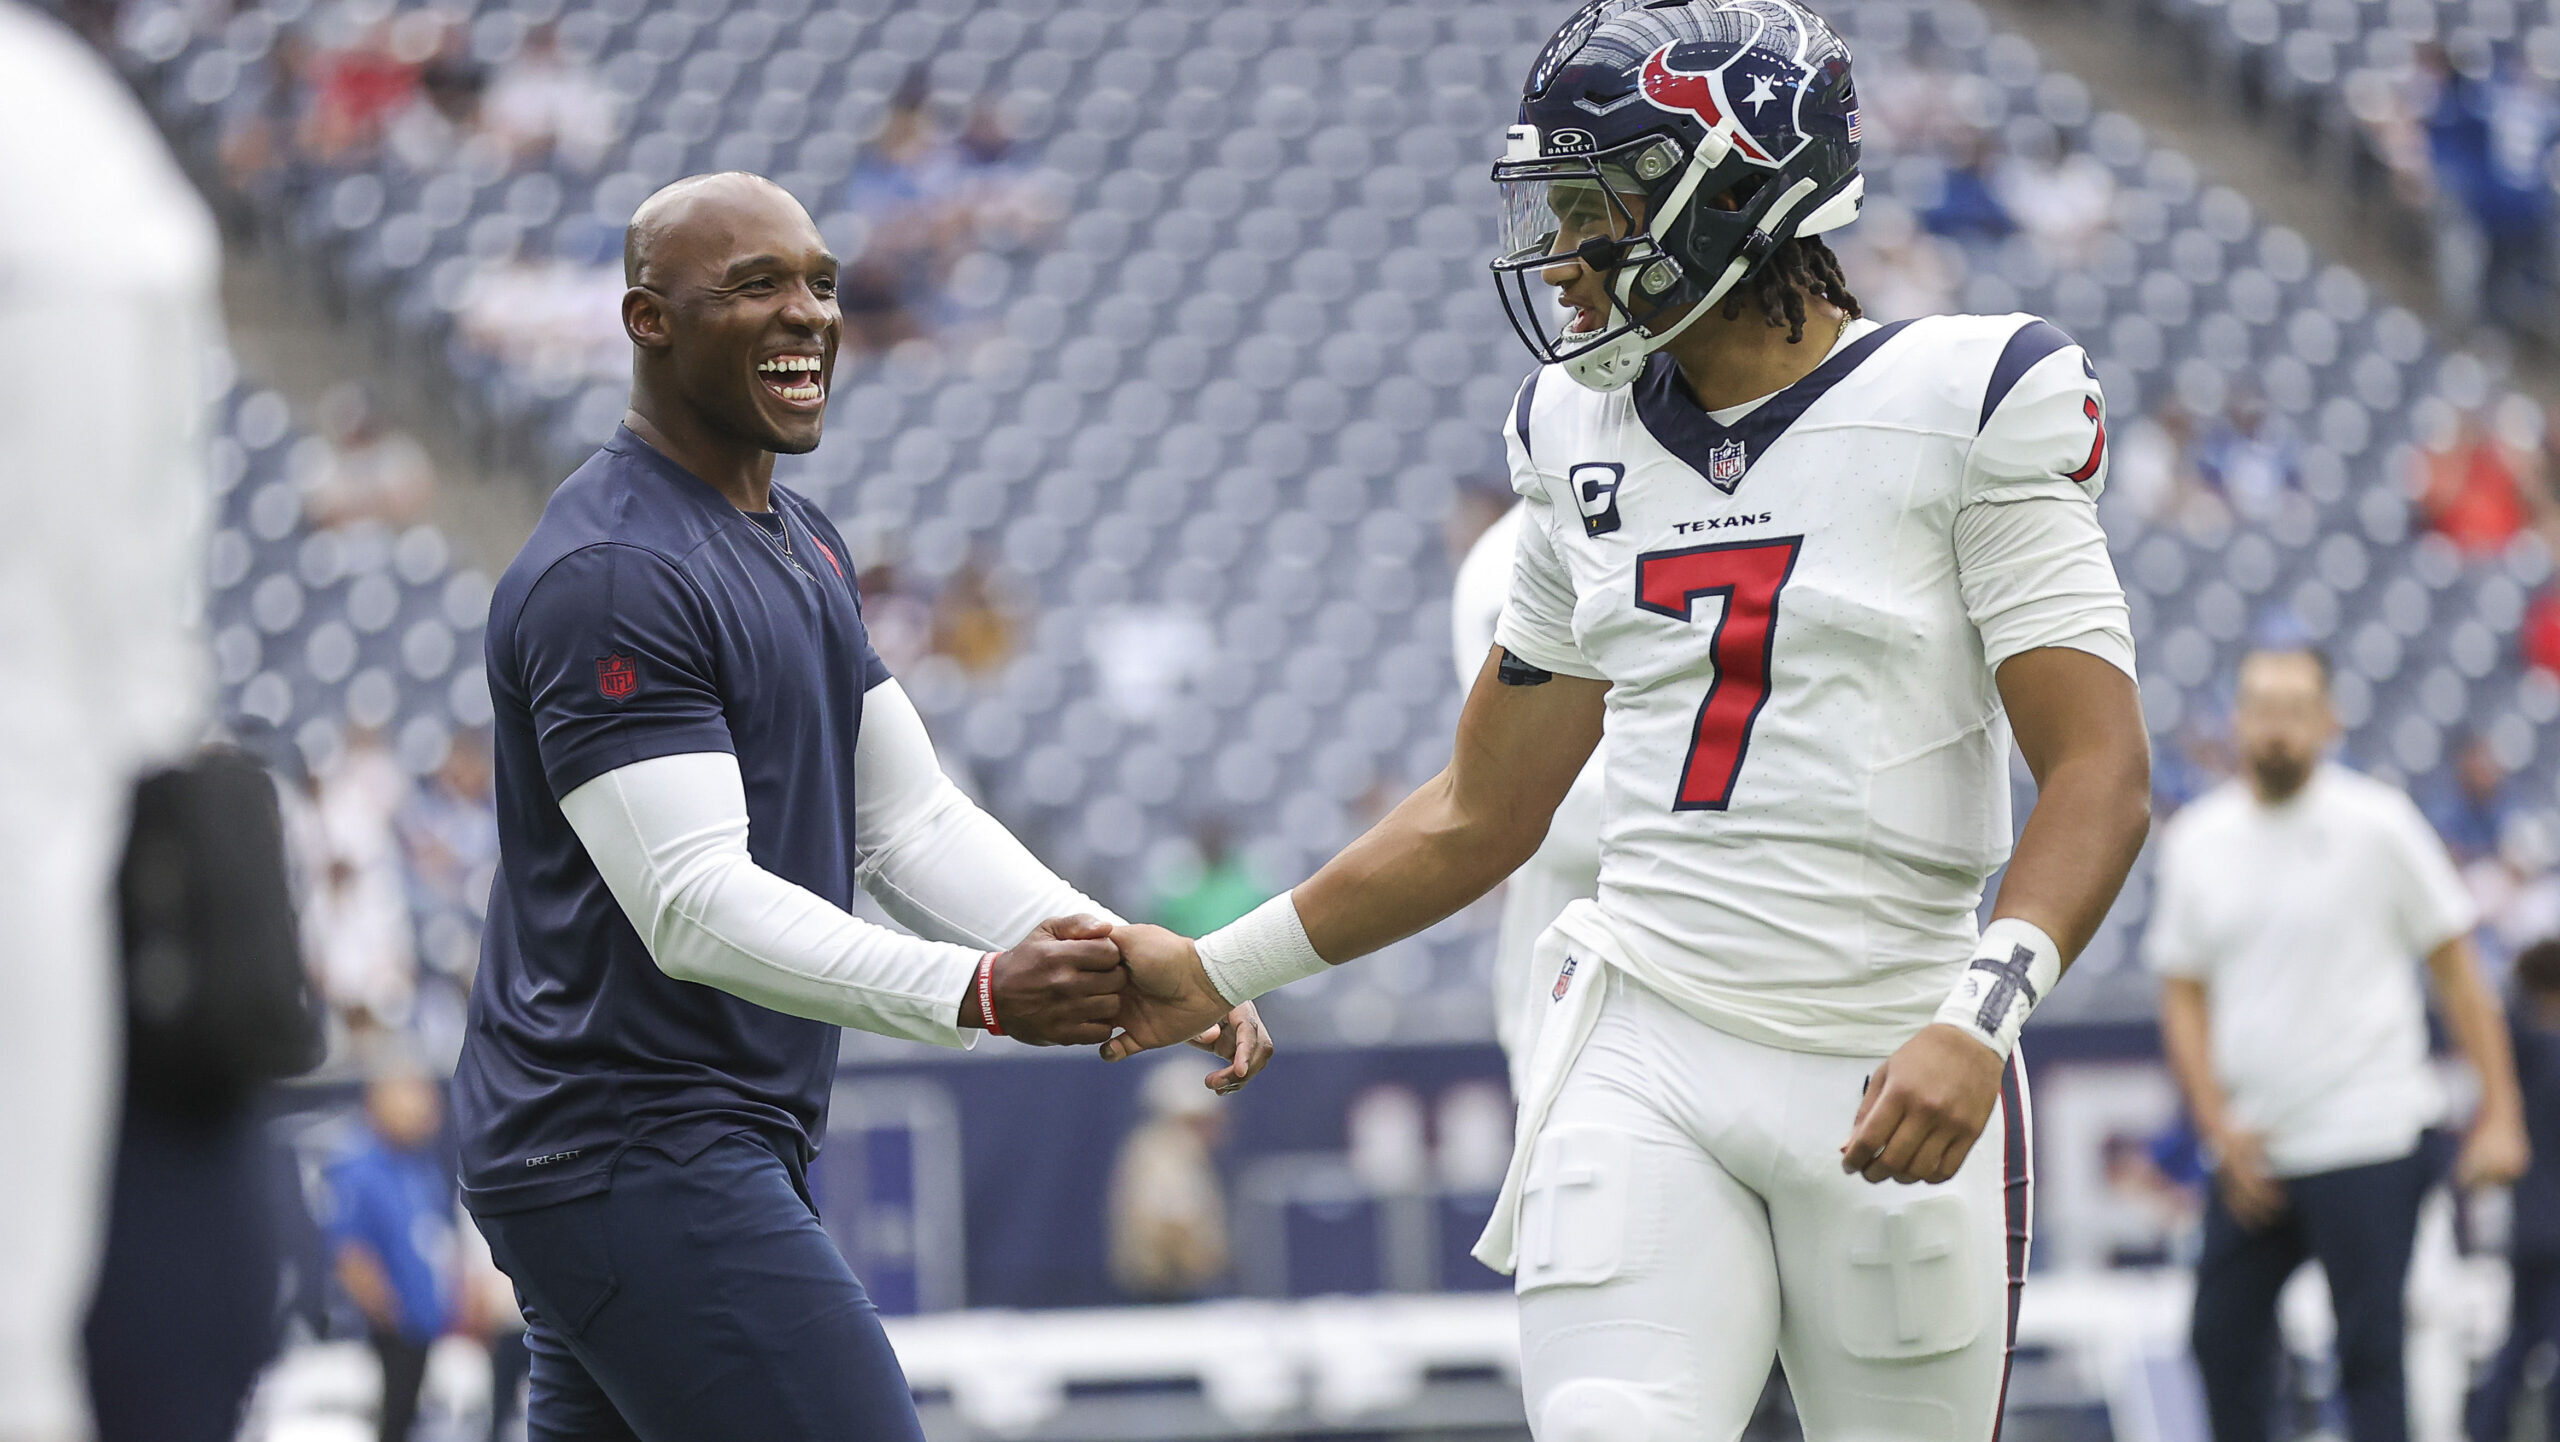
[{"x1": 1518, "y1": 968, "x2": 2030, "y2": 1442}]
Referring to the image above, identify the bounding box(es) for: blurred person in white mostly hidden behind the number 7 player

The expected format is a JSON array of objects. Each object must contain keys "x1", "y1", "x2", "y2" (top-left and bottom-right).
[{"x1": 1449, "y1": 502, "x2": 1600, "y2": 1096}]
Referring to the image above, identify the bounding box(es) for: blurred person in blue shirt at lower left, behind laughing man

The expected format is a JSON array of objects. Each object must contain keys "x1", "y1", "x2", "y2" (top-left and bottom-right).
[{"x1": 325, "y1": 1063, "x2": 461, "y2": 1442}]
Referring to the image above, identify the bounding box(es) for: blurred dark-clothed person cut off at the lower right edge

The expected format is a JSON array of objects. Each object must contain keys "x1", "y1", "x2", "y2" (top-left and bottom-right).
[{"x1": 2470, "y1": 937, "x2": 2560, "y2": 1442}]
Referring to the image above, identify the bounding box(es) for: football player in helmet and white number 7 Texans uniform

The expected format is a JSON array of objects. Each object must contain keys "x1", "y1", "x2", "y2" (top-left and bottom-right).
[{"x1": 1106, "y1": 0, "x2": 2150, "y2": 1442}]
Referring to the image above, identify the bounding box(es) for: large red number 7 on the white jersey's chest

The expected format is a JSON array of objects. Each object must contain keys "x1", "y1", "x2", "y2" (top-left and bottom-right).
[{"x1": 1636, "y1": 535, "x2": 1805, "y2": 812}]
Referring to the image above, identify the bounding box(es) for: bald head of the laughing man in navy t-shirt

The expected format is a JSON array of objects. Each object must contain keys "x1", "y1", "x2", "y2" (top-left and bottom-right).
[{"x1": 622, "y1": 174, "x2": 845, "y2": 456}]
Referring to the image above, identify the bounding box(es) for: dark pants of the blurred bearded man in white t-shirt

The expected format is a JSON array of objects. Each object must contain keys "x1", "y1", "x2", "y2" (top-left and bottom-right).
[{"x1": 2191, "y1": 1147, "x2": 2435, "y2": 1442}]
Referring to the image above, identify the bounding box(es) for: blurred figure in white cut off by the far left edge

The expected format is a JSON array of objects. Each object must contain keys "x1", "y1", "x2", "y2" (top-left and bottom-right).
[{"x1": 0, "y1": 0, "x2": 220, "y2": 1442}]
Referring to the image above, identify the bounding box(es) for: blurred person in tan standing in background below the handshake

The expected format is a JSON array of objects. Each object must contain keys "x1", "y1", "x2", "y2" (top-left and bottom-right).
[{"x1": 1108, "y1": 1058, "x2": 1229, "y2": 1301}]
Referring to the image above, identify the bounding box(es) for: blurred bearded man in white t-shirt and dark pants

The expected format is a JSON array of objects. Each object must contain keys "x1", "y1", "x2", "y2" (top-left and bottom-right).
[{"x1": 2145, "y1": 651, "x2": 2529, "y2": 1442}]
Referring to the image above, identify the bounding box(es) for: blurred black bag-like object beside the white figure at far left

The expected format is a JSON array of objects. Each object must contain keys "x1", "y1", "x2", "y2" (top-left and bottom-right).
[{"x1": 115, "y1": 748, "x2": 323, "y2": 1117}]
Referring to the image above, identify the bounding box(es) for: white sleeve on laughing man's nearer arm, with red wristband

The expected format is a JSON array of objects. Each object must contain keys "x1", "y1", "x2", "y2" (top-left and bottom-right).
[{"x1": 561, "y1": 750, "x2": 983, "y2": 1048}]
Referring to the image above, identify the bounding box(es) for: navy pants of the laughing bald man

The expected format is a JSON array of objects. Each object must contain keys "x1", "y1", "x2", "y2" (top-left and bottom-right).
[{"x1": 479, "y1": 1132, "x2": 924, "y2": 1442}]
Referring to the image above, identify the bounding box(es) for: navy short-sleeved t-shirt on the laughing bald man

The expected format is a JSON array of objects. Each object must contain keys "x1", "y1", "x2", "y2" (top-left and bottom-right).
[{"x1": 453, "y1": 430, "x2": 890, "y2": 1211}]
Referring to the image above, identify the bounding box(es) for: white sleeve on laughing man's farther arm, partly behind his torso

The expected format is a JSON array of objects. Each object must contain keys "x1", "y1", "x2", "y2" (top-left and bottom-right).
[{"x1": 852, "y1": 681, "x2": 1119, "y2": 948}]
